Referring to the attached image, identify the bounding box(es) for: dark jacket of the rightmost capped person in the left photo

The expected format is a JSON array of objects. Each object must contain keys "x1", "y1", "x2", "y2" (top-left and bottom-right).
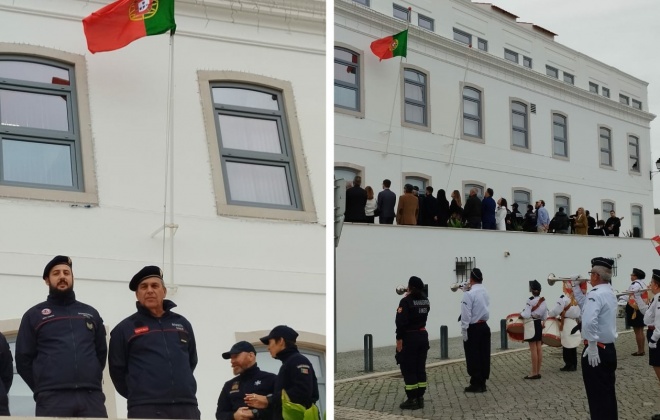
[{"x1": 271, "y1": 346, "x2": 319, "y2": 420}]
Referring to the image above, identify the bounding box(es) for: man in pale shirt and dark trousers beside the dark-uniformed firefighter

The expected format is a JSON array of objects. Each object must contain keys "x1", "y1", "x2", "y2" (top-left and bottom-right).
[{"x1": 460, "y1": 268, "x2": 490, "y2": 392}]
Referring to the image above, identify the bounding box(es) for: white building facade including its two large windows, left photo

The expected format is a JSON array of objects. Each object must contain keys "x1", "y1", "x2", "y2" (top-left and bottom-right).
[{"x1": 0, "y1": 0, "x2": 326, "y2": 418}]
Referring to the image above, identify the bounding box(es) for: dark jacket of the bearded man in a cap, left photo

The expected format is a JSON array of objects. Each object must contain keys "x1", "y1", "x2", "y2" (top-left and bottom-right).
[{"x1": 215, "y1": 363, "x2": 277, "y2": 420}]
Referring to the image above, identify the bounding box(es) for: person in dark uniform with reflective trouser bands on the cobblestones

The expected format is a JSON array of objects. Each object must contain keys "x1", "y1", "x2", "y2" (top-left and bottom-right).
[{"x1": 395, "y1": 276, "x2": 431, "y2": 410}]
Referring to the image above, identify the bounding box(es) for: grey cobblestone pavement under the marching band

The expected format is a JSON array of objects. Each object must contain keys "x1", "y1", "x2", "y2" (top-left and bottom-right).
[{"x1": 334, "y1": 322, "x2": 660, "y2": 420}]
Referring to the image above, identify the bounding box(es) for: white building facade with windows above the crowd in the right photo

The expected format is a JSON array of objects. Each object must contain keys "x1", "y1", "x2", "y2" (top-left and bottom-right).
[{"x1": 335, "y1": 0, "x2": 655, "y2": 237}]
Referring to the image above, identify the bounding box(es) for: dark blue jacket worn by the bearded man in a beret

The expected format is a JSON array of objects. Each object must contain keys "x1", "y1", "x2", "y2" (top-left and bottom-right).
[{"x1": 16, "y1": 290, "x2": 108, "y2": 395}]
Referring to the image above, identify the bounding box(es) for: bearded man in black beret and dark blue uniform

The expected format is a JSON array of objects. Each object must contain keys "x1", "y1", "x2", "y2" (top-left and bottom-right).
[{"x1": 16, "y1": 255, "x2": 108, "y2": 418}]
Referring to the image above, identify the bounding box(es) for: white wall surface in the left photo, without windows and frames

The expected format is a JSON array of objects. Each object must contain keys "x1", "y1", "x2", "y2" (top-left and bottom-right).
[{"x1": 0, "y1": 0, "x2": 325, "y2": 418}]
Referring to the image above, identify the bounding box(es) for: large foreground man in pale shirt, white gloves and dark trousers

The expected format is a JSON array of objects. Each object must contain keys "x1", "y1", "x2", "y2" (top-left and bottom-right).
[{"x1": 573, "y1": 257, "x2": 618, "y2": 420}]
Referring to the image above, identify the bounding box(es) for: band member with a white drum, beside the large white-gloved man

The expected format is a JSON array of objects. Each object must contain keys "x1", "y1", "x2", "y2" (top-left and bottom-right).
[{"x1": 548, "y1": 281, "x2": 587, "y2": 372}]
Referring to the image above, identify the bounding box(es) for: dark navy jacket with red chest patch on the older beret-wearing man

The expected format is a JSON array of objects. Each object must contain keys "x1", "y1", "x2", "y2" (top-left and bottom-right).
[{"x1": 108, "y1": 300, "x2": 197, "y2": 408}]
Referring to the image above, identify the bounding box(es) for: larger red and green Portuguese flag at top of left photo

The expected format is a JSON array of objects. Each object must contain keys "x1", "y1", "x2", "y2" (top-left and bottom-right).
[{"x1": 83, "y1": 0, "x2": 176, "y2": 53}]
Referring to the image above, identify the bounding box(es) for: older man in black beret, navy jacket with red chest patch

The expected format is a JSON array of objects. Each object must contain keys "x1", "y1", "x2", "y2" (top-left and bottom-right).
[{"x1": 108, "y1": 265, "x2": 200, "y2": 419}]
